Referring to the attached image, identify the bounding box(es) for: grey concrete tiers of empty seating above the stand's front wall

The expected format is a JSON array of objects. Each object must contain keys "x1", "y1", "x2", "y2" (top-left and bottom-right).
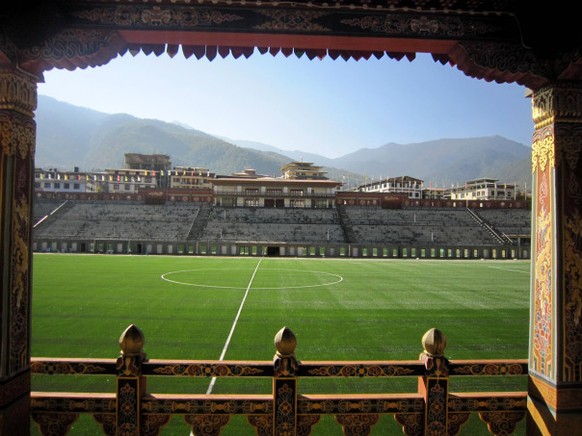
[{"x1": 33, "y1": 199, "x2": 530, "y2": 246}]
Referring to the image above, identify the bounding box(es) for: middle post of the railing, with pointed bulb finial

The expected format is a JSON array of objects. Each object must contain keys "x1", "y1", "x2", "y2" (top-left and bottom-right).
[{"x1": 273, "y1": 327, "x2": 299, "y2": 436}]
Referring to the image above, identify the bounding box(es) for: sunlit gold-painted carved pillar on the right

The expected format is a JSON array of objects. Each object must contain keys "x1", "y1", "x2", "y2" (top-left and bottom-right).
[{"x1": 528, "y1": 82, "x2": 582, "y2": 435}]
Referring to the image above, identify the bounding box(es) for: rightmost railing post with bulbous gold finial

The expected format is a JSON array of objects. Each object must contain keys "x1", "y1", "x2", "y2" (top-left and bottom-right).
[{"x1": 418, "y1": 328, "x2": 449, "y2": 436}]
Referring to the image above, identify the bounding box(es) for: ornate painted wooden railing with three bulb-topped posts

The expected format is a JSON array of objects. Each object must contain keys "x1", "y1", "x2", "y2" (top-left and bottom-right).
[{"x1": 31, "y1": 325, "x2": 528, "y2": 436}]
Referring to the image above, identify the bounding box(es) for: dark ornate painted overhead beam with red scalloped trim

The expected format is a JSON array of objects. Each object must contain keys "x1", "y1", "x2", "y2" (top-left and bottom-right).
[{"x1": 0, "y1": 0, "x2": 581, "y2": 89}]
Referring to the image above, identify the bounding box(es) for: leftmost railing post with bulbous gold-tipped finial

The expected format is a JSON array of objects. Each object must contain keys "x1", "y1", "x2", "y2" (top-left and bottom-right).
[{"x1": 115, "y1": 324, "x2": 146, "y2": 436}]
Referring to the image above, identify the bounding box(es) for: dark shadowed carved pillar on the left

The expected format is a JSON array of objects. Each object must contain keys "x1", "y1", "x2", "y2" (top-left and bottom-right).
[{"x1": 0, "y1": 65, "x2": 38, "y2": 435}]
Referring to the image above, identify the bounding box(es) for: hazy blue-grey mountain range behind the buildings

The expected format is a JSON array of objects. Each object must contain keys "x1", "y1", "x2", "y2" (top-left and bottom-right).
[{"x1": 36, "y1": 95, "x2": 531, "y2": 187}]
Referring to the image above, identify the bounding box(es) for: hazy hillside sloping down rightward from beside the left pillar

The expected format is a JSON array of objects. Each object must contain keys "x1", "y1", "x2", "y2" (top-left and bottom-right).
[{"x1": 36, "y1": 95, "x2": 362, "y2": 179}]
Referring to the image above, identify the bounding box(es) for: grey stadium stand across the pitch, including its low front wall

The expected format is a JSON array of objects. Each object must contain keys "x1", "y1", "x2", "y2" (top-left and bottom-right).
[{"x1": 33, "y1": 198, "x2": 530, "y2": 258}]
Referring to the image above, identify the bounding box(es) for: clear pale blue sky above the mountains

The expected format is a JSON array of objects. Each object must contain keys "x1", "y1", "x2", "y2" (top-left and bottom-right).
[{"x1": 38, "y1": 51, "x2": 533, "y2": 157}]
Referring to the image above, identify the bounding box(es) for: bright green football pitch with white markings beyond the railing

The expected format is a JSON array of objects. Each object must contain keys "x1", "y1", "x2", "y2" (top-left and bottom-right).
[{"x1": 32, "y1": 254, "x2": 530, "y2": 435}]
